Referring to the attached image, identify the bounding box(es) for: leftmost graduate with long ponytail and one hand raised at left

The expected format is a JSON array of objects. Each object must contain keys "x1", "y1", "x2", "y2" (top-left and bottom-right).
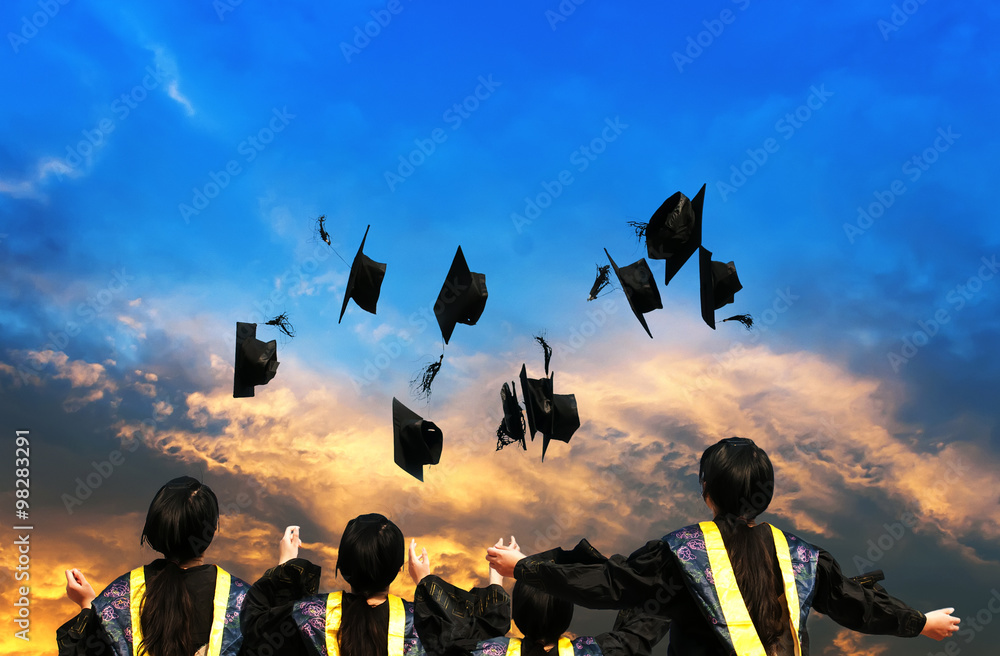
[{"x1": 56, "y1": 476, "x2": 250, "y2": 656}]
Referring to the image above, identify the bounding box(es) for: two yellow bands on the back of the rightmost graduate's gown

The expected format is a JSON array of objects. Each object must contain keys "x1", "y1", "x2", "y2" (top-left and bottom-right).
[{"x1": 698, "y1": 522, "x2": 801, "y2": 656}]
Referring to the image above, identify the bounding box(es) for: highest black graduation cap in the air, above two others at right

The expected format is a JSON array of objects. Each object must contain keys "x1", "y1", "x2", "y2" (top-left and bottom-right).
[{"x1": 646, "y1": 185, "x2": 705, "y2": 285}]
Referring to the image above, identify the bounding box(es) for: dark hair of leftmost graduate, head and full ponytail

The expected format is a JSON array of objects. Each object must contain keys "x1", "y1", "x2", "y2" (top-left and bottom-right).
[{"x1": 136, "y1": 476, "x2": 219, "y2": 656}]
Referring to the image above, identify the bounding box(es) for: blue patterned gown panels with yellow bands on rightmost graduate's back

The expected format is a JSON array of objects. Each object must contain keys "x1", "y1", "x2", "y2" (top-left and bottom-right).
[{"x1": 663, "y1": 522, "x2": 819, "y2": 655}]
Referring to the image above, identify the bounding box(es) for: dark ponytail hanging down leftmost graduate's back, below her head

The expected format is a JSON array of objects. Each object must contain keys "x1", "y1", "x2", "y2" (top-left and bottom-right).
[{"x1": 136, "y1": 561, "x2": 200, "y2": 656}]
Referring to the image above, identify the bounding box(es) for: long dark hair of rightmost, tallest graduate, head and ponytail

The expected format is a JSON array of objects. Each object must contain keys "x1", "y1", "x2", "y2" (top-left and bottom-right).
[{"x1": 698, "y1": 437, "x2": 788, "y2": 653}]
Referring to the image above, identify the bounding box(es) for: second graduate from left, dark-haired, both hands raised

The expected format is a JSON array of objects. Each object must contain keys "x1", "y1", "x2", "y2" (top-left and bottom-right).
[{"x1": 241, "y1": 514, "x2": 510, "y2": 656}]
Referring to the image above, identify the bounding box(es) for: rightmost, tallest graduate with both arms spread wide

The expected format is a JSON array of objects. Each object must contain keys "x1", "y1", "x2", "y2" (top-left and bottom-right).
[{"x1": 487, "y1": 437, "x2": 959, "y2": 656}]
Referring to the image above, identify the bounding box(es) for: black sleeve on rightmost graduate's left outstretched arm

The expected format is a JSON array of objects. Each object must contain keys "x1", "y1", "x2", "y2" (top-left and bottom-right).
[{"x1": 514, "y1": 540, "x2": 683, "y2": 615}]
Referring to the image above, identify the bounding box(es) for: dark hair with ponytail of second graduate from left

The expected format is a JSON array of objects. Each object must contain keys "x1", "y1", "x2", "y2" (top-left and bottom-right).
[{"x1": 336, "y1": 513, "x2": 406, "y2": 656}]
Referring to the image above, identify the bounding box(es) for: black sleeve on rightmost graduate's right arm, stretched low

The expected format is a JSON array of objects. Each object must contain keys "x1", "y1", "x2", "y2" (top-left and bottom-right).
[{"x1": 813, "y1": 549, "x2": 927, "y2": 638}]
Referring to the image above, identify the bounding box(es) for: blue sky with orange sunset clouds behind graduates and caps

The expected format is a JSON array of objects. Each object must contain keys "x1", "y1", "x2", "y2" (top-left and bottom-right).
[{"x1": 0, "y1": 0, "x2": 1000, "y2": 656}]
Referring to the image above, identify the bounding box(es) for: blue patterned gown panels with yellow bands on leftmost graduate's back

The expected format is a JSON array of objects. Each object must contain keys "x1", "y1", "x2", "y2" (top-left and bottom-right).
[{"x1": 92, "y1": 566, "x2": 249, "y2": 656}]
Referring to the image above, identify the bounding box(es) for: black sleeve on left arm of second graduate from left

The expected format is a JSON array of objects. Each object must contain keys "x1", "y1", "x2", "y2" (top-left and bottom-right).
[{"x1": 240, "y1": 558, "x2": 322, "y2": 656}]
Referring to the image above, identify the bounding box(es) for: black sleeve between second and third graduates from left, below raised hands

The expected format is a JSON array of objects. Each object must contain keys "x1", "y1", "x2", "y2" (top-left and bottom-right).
[{"x1": 413, "y1": 574, "x2": 510, "y2": 654}]
